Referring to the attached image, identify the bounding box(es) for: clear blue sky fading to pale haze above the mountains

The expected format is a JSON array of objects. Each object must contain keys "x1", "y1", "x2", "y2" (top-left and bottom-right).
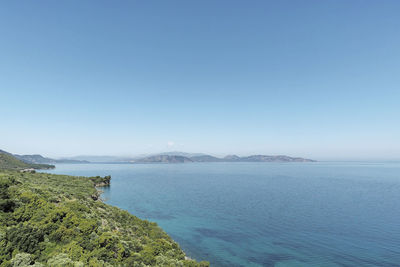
[{"x1": 0, "y1": 0, "x2": 400, "y2": 160}]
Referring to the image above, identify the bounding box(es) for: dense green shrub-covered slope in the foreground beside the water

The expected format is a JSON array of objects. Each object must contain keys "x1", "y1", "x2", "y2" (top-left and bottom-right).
[{"x1": 0, "y1": 170, "x2": 209, "y2": 267}]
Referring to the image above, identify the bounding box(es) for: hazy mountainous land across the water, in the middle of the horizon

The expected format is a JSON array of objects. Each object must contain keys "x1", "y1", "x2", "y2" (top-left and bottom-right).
[{"x1": 133, "y1": 153, "x2": 315, "y2": 163}]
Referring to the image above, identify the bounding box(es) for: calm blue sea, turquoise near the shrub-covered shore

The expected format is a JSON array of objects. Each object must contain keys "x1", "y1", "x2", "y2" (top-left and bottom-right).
[{"x1": 45, "y1": 162, "x2": 400, "y2": 266}]
